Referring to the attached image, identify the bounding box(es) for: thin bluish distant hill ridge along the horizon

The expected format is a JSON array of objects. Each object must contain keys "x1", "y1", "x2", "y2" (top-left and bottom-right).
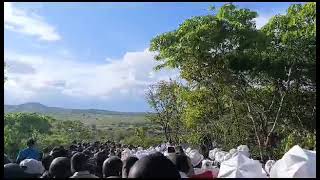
[{"x1": 4, "y1": 102, "x2": 145, "y2": 116}]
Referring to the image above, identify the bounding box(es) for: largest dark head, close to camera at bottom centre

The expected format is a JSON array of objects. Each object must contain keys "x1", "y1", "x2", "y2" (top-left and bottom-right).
[{"x1": 128, "y1": 154, "x2": 180, "y2": 178}]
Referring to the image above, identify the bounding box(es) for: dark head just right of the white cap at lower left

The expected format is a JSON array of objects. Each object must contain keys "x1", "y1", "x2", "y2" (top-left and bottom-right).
[{"x1": 49, "y1": 157, "x2": 72, "y2": 178}]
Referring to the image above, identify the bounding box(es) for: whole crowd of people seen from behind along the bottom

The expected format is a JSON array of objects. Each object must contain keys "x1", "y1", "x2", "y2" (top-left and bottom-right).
[{"x1": 4, "y1": 139, "x2": 316, "y2": 179}]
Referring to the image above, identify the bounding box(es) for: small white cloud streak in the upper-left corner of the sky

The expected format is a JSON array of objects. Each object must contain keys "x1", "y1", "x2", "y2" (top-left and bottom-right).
[{"x1": 4, "y1": 2, "x2": 61, "y2": 41}]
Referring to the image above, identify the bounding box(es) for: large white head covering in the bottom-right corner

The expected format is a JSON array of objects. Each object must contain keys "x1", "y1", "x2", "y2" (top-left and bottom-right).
[{"x1": 270, "y1": 145, "x2": 316, "y2": 178}]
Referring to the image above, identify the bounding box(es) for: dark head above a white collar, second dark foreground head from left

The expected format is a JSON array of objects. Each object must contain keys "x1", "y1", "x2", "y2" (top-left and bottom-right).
[{"x1": 71, "y1": 152, "x2": 88, "y2": 173}]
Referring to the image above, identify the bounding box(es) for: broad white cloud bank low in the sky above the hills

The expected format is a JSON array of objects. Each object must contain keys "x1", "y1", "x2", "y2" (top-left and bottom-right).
[{"x1": 5, "y1": 50, "x2": 179, "y2": 103}]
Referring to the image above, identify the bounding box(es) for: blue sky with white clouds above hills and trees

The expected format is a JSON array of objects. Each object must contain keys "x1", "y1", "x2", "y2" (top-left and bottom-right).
[{"x1": 4, "y1": 2, "x2": 304, "y2": 112}]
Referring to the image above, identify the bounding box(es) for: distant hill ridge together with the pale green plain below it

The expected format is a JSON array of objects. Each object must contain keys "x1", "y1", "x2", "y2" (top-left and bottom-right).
[{"x1": 4, "y1": 103, "x2": 150, "y2": 130}]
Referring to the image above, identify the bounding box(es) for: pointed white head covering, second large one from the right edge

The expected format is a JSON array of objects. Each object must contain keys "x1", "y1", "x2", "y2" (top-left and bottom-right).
[{"x1": 218, "y1": 153, "x2": 267, "y2": 178}]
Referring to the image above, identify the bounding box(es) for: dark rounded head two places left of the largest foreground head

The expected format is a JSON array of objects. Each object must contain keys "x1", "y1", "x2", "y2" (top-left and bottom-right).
[{"x1": 102, "y1": 156, "x2": 122, "y2": 177}]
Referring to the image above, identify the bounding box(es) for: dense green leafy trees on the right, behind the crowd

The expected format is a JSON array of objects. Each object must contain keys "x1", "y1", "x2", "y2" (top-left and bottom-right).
[{"x1": 150, "y1": 3, "x2": 316, "y2": 159}]
